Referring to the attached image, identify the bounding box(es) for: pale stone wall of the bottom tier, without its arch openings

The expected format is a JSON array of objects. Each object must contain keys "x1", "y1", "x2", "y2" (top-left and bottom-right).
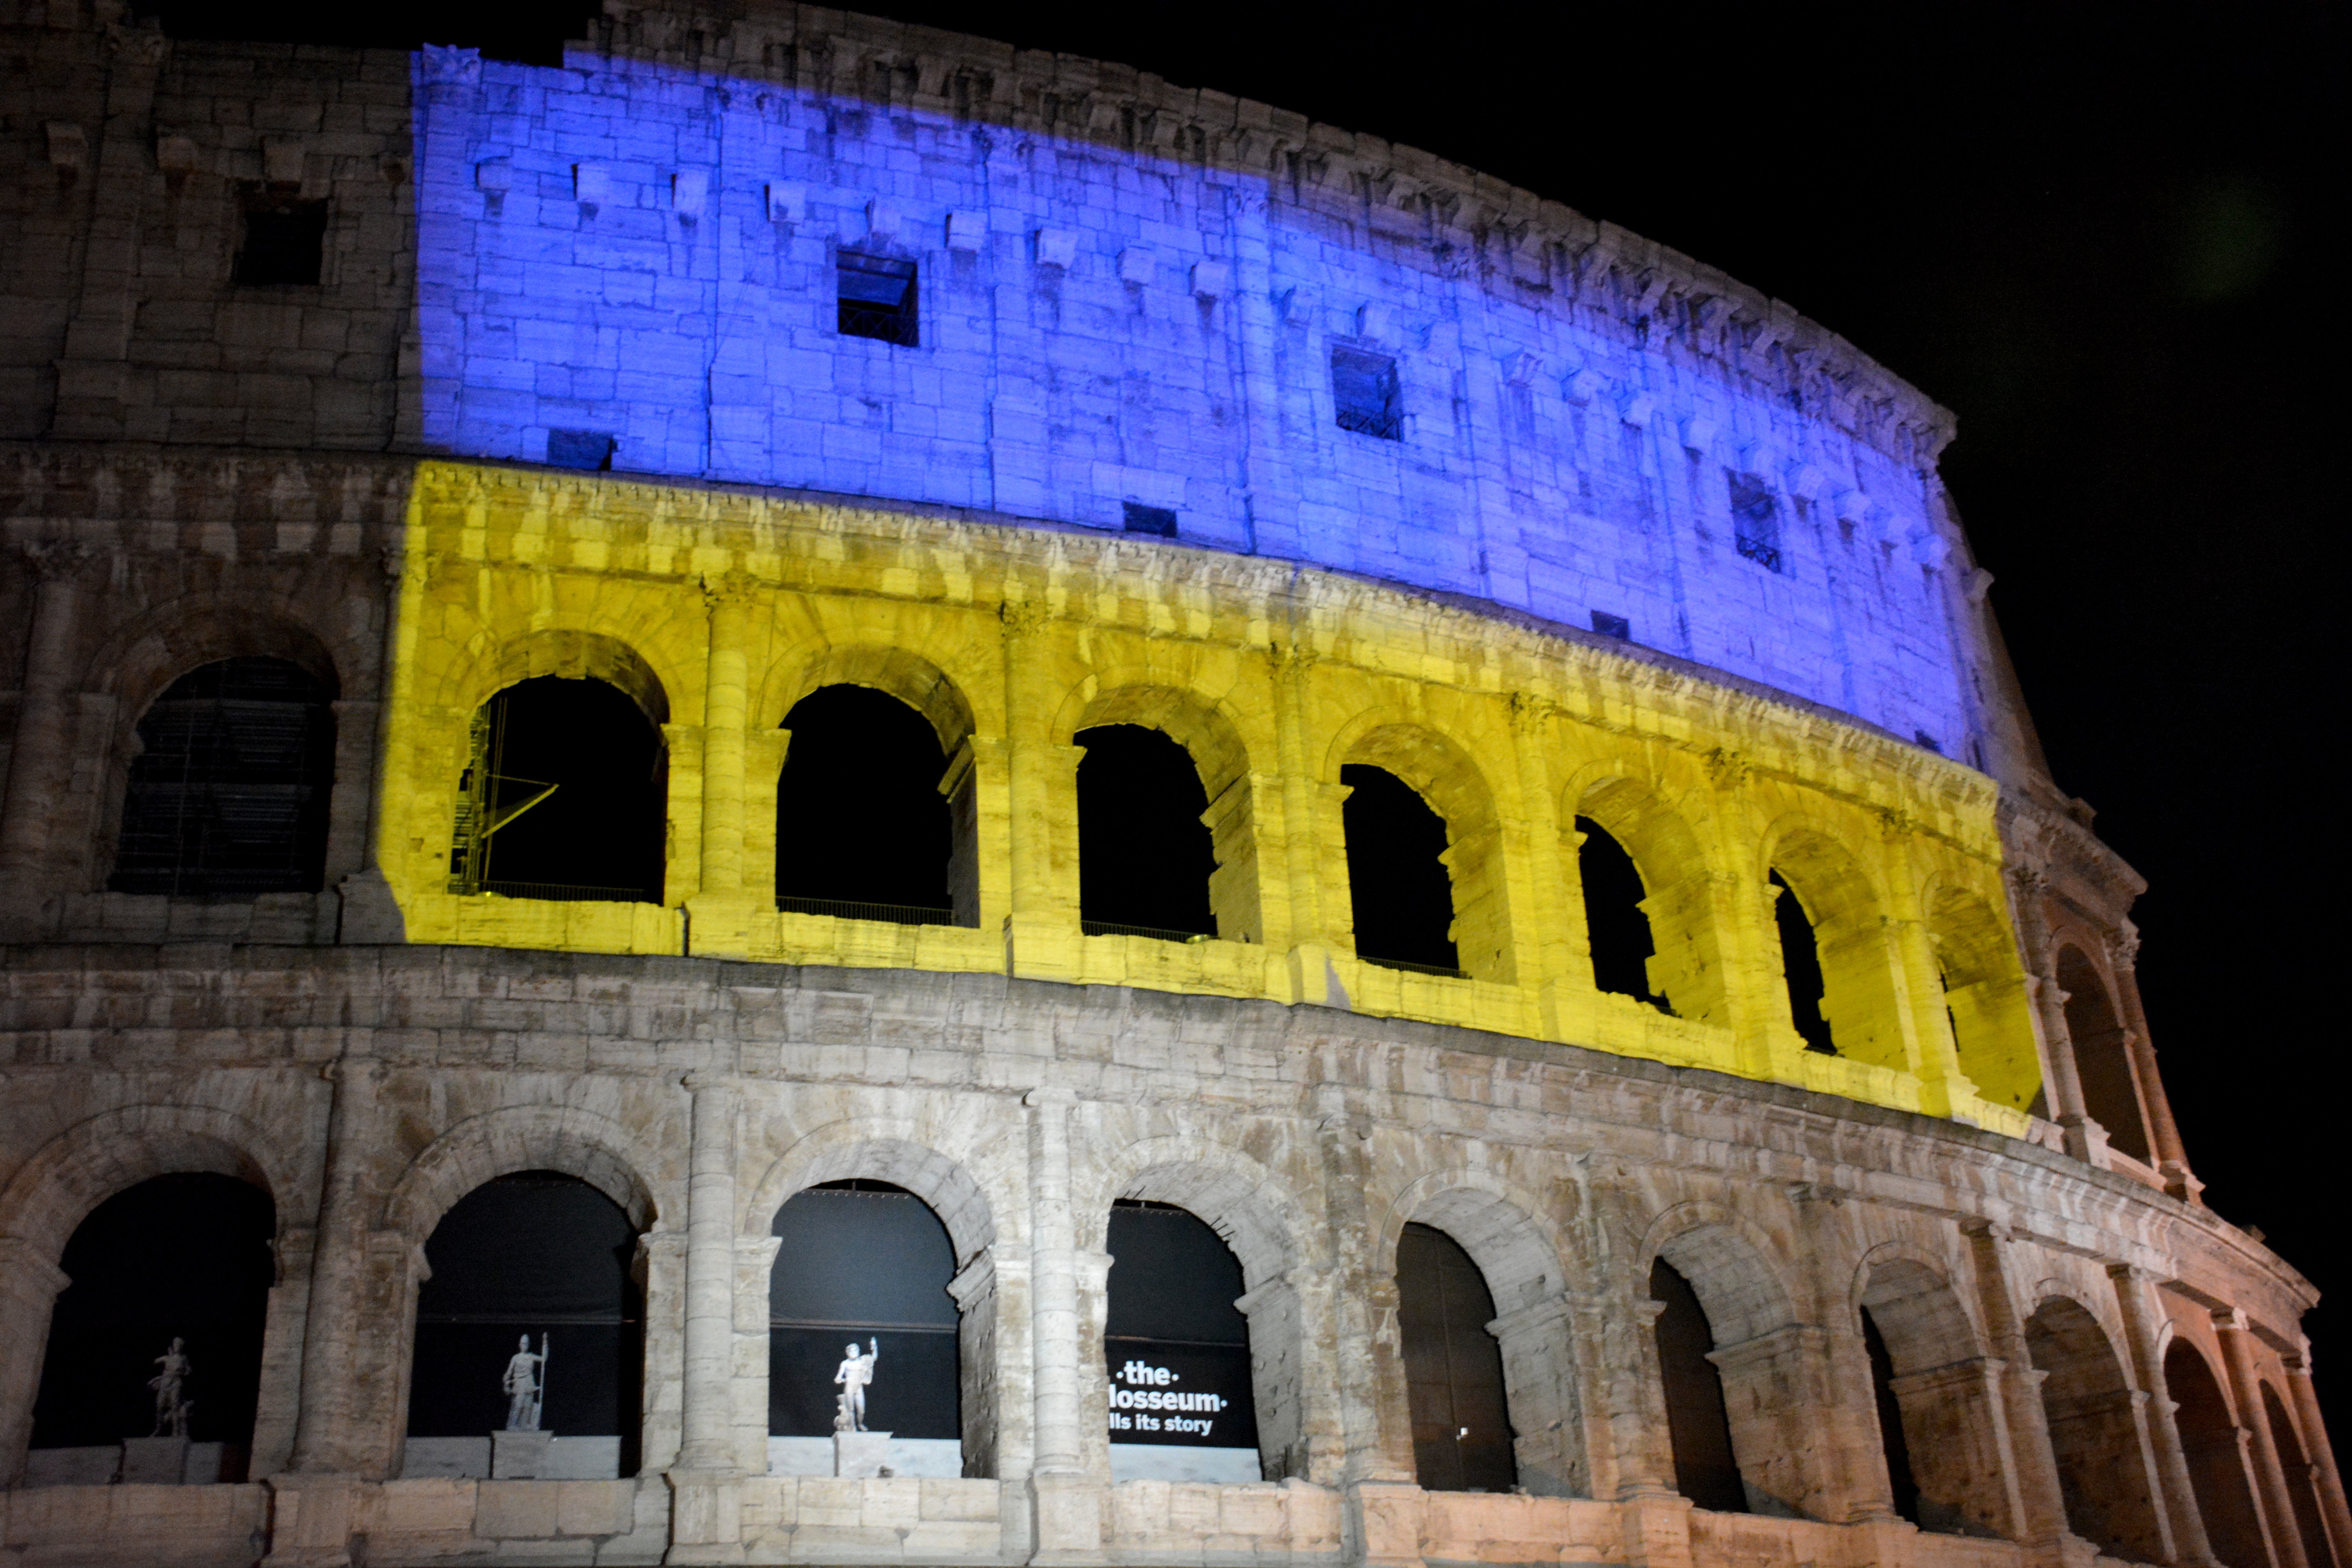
[{"x1": 0, "y1": 945, "x2": 2310, "y2": 1563}]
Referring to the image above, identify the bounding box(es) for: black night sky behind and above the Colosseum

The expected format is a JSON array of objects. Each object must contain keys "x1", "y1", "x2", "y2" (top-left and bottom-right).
[{"x1": 165, "y1": 0, "x2": 2352, "y2": 1432}]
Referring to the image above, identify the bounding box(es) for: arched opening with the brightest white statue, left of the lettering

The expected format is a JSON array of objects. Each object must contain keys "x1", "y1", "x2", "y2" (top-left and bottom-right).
[{"x1": 767, "y1": 1178, "x2": 964, "y2": 1476}]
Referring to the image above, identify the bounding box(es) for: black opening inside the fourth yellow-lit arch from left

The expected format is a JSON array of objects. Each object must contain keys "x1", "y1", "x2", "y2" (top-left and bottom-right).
[{"x1": 1338, "y1": 762, "x2": 1461, "y2": 976}]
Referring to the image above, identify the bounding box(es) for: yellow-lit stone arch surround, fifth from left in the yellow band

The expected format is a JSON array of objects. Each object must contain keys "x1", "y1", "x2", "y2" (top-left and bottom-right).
[{"x1": 1559, "y1": 771, "x2": 1729, "y2": 1023}]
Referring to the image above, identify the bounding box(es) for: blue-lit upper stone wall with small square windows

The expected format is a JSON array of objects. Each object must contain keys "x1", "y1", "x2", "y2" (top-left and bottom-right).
[{"x1": 416, "y1": 52, "x2": 1971, "y2": 757}]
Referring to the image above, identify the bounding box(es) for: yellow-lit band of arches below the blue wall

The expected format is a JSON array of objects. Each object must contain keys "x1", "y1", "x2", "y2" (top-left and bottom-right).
[{"x1": 379, "y1": 465, "x2": 2044, "y2": 1136}]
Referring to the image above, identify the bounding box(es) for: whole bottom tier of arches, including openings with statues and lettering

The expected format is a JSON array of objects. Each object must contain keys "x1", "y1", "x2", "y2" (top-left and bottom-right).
[{"x1": 0, "y1": 947, "x2": 2352, "y2": 1568}]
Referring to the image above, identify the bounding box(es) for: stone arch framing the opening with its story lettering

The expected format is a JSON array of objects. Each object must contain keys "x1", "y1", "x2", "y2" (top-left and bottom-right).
[{"x1": 1080, "y1": 1136, "x2": 1331, "y2": 1481}]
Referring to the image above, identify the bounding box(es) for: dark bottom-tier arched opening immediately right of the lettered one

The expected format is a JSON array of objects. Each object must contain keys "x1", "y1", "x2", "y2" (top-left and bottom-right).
[{"x1": 1397, "y1": 1225, "x2": 1519, "y2": 1493}]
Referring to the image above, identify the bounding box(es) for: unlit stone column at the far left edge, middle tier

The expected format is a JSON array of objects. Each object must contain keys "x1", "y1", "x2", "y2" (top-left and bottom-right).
[{"x1": 0, "y1": 541, "x2": 92, "y2": 915}]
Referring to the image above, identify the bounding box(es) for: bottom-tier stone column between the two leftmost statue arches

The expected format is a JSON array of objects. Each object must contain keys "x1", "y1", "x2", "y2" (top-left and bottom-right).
[{"x1": 289, "y1": 1056, "x2": 383, "y2": 1476}]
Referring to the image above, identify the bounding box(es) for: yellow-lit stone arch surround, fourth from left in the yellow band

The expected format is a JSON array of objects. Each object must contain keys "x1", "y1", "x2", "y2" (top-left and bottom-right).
[{"x1": 1324, "y1": 712, "x2": 1517, "y2": 983}]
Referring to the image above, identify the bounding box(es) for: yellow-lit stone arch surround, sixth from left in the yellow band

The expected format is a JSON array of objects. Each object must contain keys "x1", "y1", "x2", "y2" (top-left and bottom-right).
[{"x1": 1757, "y1": 816, "x2": 1915, "y2": 1072}]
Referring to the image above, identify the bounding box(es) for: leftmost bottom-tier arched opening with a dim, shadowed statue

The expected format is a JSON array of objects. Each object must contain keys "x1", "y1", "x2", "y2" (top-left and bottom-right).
[{"x1": 26, "y1": 1173, "x2": 275, "y2": 1486}]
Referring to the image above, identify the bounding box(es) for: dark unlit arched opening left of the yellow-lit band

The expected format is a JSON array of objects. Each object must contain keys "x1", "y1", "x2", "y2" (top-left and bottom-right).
[{"x1": 108, "y1": 658, "x2": 334, "y2": 898}]
